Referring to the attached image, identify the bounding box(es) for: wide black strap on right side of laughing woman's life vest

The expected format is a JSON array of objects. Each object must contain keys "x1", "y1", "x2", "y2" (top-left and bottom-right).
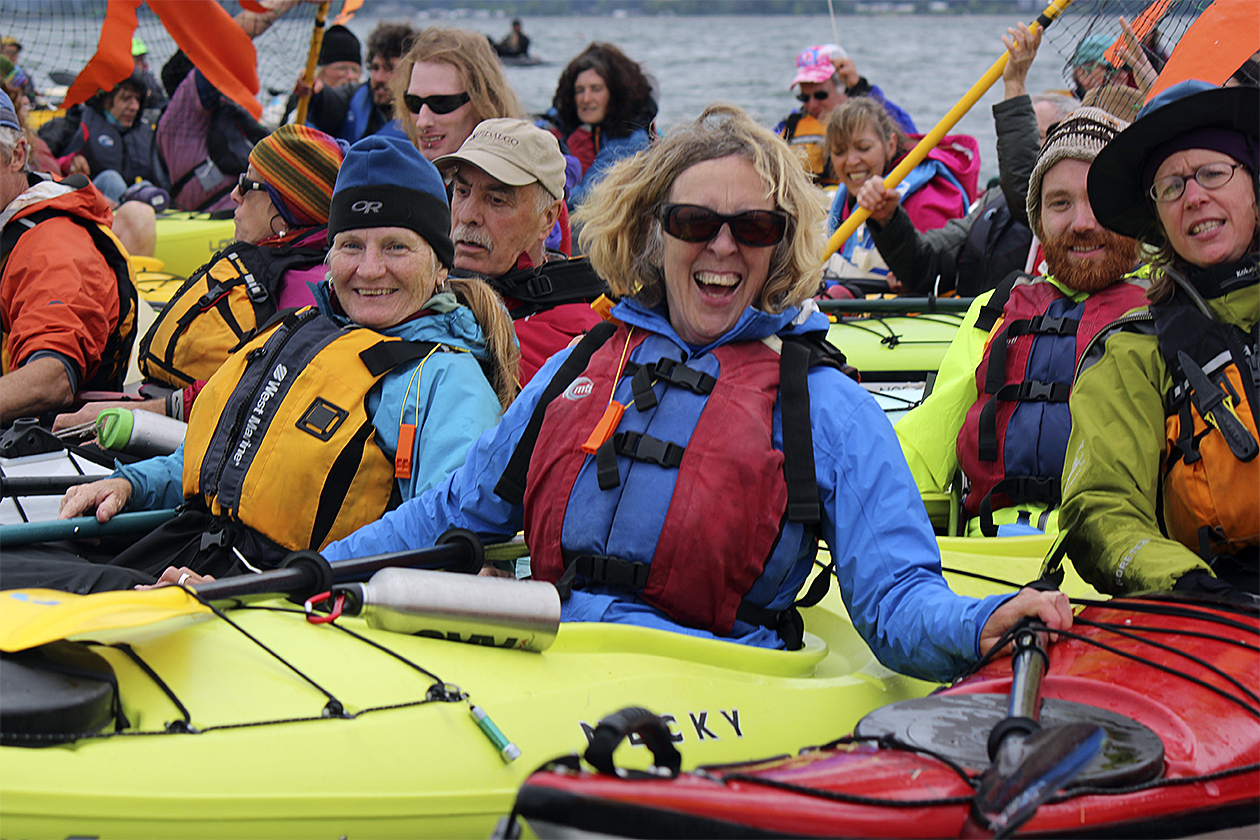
[{"x1": 779, "y1": 340, "x2": 823, "y2": 525}]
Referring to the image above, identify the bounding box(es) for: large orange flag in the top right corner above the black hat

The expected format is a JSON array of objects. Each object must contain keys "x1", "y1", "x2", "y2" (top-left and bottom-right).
[{"x1": 1147, "y1": 0, "x2": 1260, "y2": 102}]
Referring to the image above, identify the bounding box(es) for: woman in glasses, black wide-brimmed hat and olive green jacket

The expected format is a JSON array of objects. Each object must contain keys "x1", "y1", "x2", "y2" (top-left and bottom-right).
[{"x1": 1060, "y1": 81, "x2": 1260, "y2": 594}]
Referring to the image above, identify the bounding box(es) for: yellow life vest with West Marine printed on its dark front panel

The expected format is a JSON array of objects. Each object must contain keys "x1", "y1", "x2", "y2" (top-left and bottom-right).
[{"x1": 184, "y1": 307, "x2": 437, "y2": 550}]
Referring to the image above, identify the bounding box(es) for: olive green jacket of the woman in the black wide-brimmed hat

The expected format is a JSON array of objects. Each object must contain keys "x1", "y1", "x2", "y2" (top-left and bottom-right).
[{"x1": 1058, "y1": 279, "x2": 1260, "y2": 594}]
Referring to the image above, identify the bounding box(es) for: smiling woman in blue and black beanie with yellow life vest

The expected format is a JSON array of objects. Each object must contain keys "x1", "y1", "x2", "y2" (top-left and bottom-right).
[{"x1": 31, "y1": 136, "x2": 519, "y2": 592}]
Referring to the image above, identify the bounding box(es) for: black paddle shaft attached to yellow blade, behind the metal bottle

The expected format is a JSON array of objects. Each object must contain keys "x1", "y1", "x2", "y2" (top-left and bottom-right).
[{"x1": 197, "y1": 528, "x2": 485, "y2": 602}]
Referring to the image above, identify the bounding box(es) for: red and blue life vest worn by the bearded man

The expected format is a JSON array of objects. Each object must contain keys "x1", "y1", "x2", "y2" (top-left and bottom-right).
[{"x1": 958, "y1": 275, "x2": 1149, "y2": 536}]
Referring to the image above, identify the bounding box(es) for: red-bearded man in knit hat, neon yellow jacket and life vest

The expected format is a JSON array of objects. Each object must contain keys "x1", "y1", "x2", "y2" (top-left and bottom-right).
[{"x1": 896, "y1": 107, "x2": 1149, "y2": 536}]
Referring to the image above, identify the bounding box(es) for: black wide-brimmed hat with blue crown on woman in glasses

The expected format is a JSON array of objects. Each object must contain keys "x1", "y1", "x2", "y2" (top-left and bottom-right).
[{"x1": 1087, "y1": 79, "x2": 1260, "y2": 242}]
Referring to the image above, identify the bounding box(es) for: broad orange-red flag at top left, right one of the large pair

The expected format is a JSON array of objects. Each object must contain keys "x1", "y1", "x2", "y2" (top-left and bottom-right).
[{"x1": 147, "y1": 0, "x2": 262, "y2": 120}]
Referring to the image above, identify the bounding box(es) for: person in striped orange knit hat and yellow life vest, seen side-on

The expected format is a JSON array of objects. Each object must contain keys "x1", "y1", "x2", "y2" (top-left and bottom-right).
[{"x1": 53, "y1": 126, "x2": 347, "y2": 429}]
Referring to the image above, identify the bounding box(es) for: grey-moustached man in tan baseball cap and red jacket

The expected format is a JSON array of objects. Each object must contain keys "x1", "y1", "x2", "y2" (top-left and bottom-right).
[{"x1": 433, "y1": 118, "x2": 605, "y2": 384}]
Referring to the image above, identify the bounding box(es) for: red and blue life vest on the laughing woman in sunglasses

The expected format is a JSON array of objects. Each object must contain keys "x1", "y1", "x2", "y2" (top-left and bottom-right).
[{"x1": 496, "y1": 324, "x2": 838, "y2": 647}]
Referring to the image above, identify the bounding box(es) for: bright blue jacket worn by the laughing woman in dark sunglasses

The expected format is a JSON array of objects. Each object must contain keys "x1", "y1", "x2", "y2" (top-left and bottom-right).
[{"x1": 324, "y1": 295, "x2": 1009, "y2": 680}]
